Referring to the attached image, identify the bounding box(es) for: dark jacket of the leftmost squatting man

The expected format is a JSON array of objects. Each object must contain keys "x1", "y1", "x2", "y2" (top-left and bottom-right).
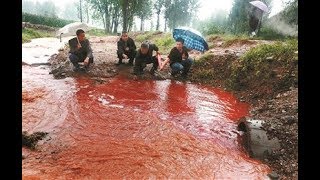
[{"x1": 69, "y1": 37, "x2": 93, "y2": 58}]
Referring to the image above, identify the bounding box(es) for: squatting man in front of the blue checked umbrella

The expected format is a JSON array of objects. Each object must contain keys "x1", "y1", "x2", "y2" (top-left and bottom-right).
[{"x1": 160, "y1": 38, "x2": 193, "y2": 78}]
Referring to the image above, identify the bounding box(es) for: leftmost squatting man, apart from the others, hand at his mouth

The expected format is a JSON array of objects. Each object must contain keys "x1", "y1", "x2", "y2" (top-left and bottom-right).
[{"x1": 69, "y1": 29, "x2": 93, "y2": 71}]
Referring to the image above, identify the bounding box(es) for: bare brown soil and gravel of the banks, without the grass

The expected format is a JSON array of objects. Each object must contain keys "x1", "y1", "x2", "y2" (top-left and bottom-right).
[{"x1": 44, "y1": 36, "x2": 298, "y2": 179}]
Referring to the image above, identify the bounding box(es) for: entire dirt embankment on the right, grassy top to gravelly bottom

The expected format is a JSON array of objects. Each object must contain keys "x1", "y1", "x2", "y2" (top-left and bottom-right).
[{"x1": 190, "y1": 37, "x2": 298, "y2": 179}]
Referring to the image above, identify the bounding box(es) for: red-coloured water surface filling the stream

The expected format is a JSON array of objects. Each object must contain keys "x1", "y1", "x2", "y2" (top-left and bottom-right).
[{"x1": 22, "y1": 68, "x2": 270, "y2": 179}]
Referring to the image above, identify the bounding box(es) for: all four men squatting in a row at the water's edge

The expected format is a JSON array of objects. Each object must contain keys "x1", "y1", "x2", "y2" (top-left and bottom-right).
[{"x1": 69, "y1": 29, "x2": 193, "y2": 78}]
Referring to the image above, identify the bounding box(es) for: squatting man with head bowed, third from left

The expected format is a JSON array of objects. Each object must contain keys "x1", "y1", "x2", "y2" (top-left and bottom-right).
[{"x1": 133, "y1": 41, "x2": 160, "y2": 75}]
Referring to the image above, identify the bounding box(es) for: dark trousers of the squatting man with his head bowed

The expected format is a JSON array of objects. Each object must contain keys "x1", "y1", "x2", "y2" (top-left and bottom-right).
[{"x1": 133, "y1": 56, "x2": 159, "y2": 74}]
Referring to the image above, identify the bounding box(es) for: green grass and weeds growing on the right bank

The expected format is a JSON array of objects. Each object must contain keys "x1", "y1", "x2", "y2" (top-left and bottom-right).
[{"x1": 227, "y1": 39, "x2": 298, "y2": 90}]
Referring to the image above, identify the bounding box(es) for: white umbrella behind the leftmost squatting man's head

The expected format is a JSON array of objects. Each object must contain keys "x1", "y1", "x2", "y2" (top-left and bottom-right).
[{"x1": 56, "y1": 22, "x2": 92, "y2": 37}]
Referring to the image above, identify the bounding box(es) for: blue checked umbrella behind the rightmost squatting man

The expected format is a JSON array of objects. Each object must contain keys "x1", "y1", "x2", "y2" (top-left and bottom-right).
[{"x1": 173, "y1": 27, "x2": 209, "y2": 52}]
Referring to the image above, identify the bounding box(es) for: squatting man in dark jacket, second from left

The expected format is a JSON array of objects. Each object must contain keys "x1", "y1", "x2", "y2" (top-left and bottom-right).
[{"x1": 116, "y1": 32, "x2": 137, "y2": 66}]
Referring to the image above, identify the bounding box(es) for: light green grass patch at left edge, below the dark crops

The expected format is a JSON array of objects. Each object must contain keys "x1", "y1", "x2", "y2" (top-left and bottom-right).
[{"x1": 22, "y1": 28, "x2": 54, "y2": 43}]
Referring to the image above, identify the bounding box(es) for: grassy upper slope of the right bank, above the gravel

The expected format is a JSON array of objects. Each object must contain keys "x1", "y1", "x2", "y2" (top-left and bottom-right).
[{"x1": 190, "y1": 40, "x2": 298, "y2": 97}]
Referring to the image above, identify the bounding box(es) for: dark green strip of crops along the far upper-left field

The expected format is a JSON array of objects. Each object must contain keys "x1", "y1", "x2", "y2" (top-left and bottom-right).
[{"x1": 22, "y1": 13, "x2": 74, "y2": 27}]
